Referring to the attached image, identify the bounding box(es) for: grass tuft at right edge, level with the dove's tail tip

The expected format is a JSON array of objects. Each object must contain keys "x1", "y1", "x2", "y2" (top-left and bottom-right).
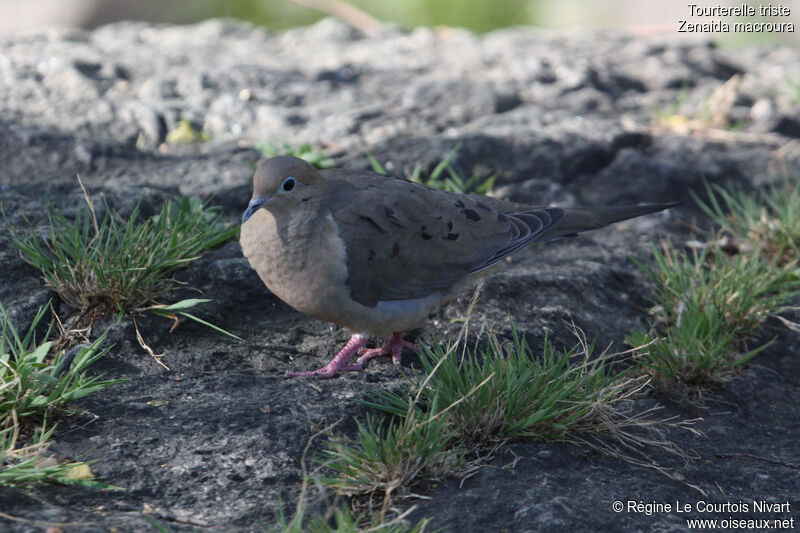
[{"x1": 692, "y1": 179, "x2": 800, "y2": 265}]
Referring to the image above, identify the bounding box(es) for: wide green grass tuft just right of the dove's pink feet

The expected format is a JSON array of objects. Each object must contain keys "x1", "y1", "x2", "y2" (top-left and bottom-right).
[{"x1": 369, "y1": 326, "x2": 668, "y2": 455}]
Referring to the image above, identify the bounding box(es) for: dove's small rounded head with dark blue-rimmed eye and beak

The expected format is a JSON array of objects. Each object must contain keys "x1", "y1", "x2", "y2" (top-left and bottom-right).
[{"x1": 242, "y1": 155, "x2": 324, "y2": 224}]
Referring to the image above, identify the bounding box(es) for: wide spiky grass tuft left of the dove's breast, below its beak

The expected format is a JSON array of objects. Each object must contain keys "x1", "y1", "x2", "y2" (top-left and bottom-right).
[{"x1": 6, "y1": 196, "x2": 238, "y2": 336}]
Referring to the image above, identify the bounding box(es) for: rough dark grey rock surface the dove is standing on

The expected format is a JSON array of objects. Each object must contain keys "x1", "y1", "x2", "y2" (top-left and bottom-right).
[{"x1": 0, "y1": 16, "x2": 800, "y2": 531}]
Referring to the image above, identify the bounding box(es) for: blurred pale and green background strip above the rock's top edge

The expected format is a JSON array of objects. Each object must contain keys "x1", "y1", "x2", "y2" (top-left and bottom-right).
[{"x1": 0, "y1": 0, "x2": 800, "y2": 46}]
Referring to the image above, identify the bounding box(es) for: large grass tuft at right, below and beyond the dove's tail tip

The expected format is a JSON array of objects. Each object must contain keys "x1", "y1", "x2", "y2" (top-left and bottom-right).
[{"x1": 627, "y1": 243, "x2": 800, "y2": 397}]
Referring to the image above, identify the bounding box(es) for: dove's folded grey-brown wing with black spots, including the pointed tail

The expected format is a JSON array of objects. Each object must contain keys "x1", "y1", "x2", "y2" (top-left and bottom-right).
[{"x1": 323, "y1": 169, "x2": 675, "y2": 306}]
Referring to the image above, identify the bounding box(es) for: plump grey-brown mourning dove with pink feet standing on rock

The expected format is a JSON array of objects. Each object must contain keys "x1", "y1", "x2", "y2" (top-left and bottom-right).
[{"x1": 241, "y1": 156, "x2": 676, "y2": 378}]
